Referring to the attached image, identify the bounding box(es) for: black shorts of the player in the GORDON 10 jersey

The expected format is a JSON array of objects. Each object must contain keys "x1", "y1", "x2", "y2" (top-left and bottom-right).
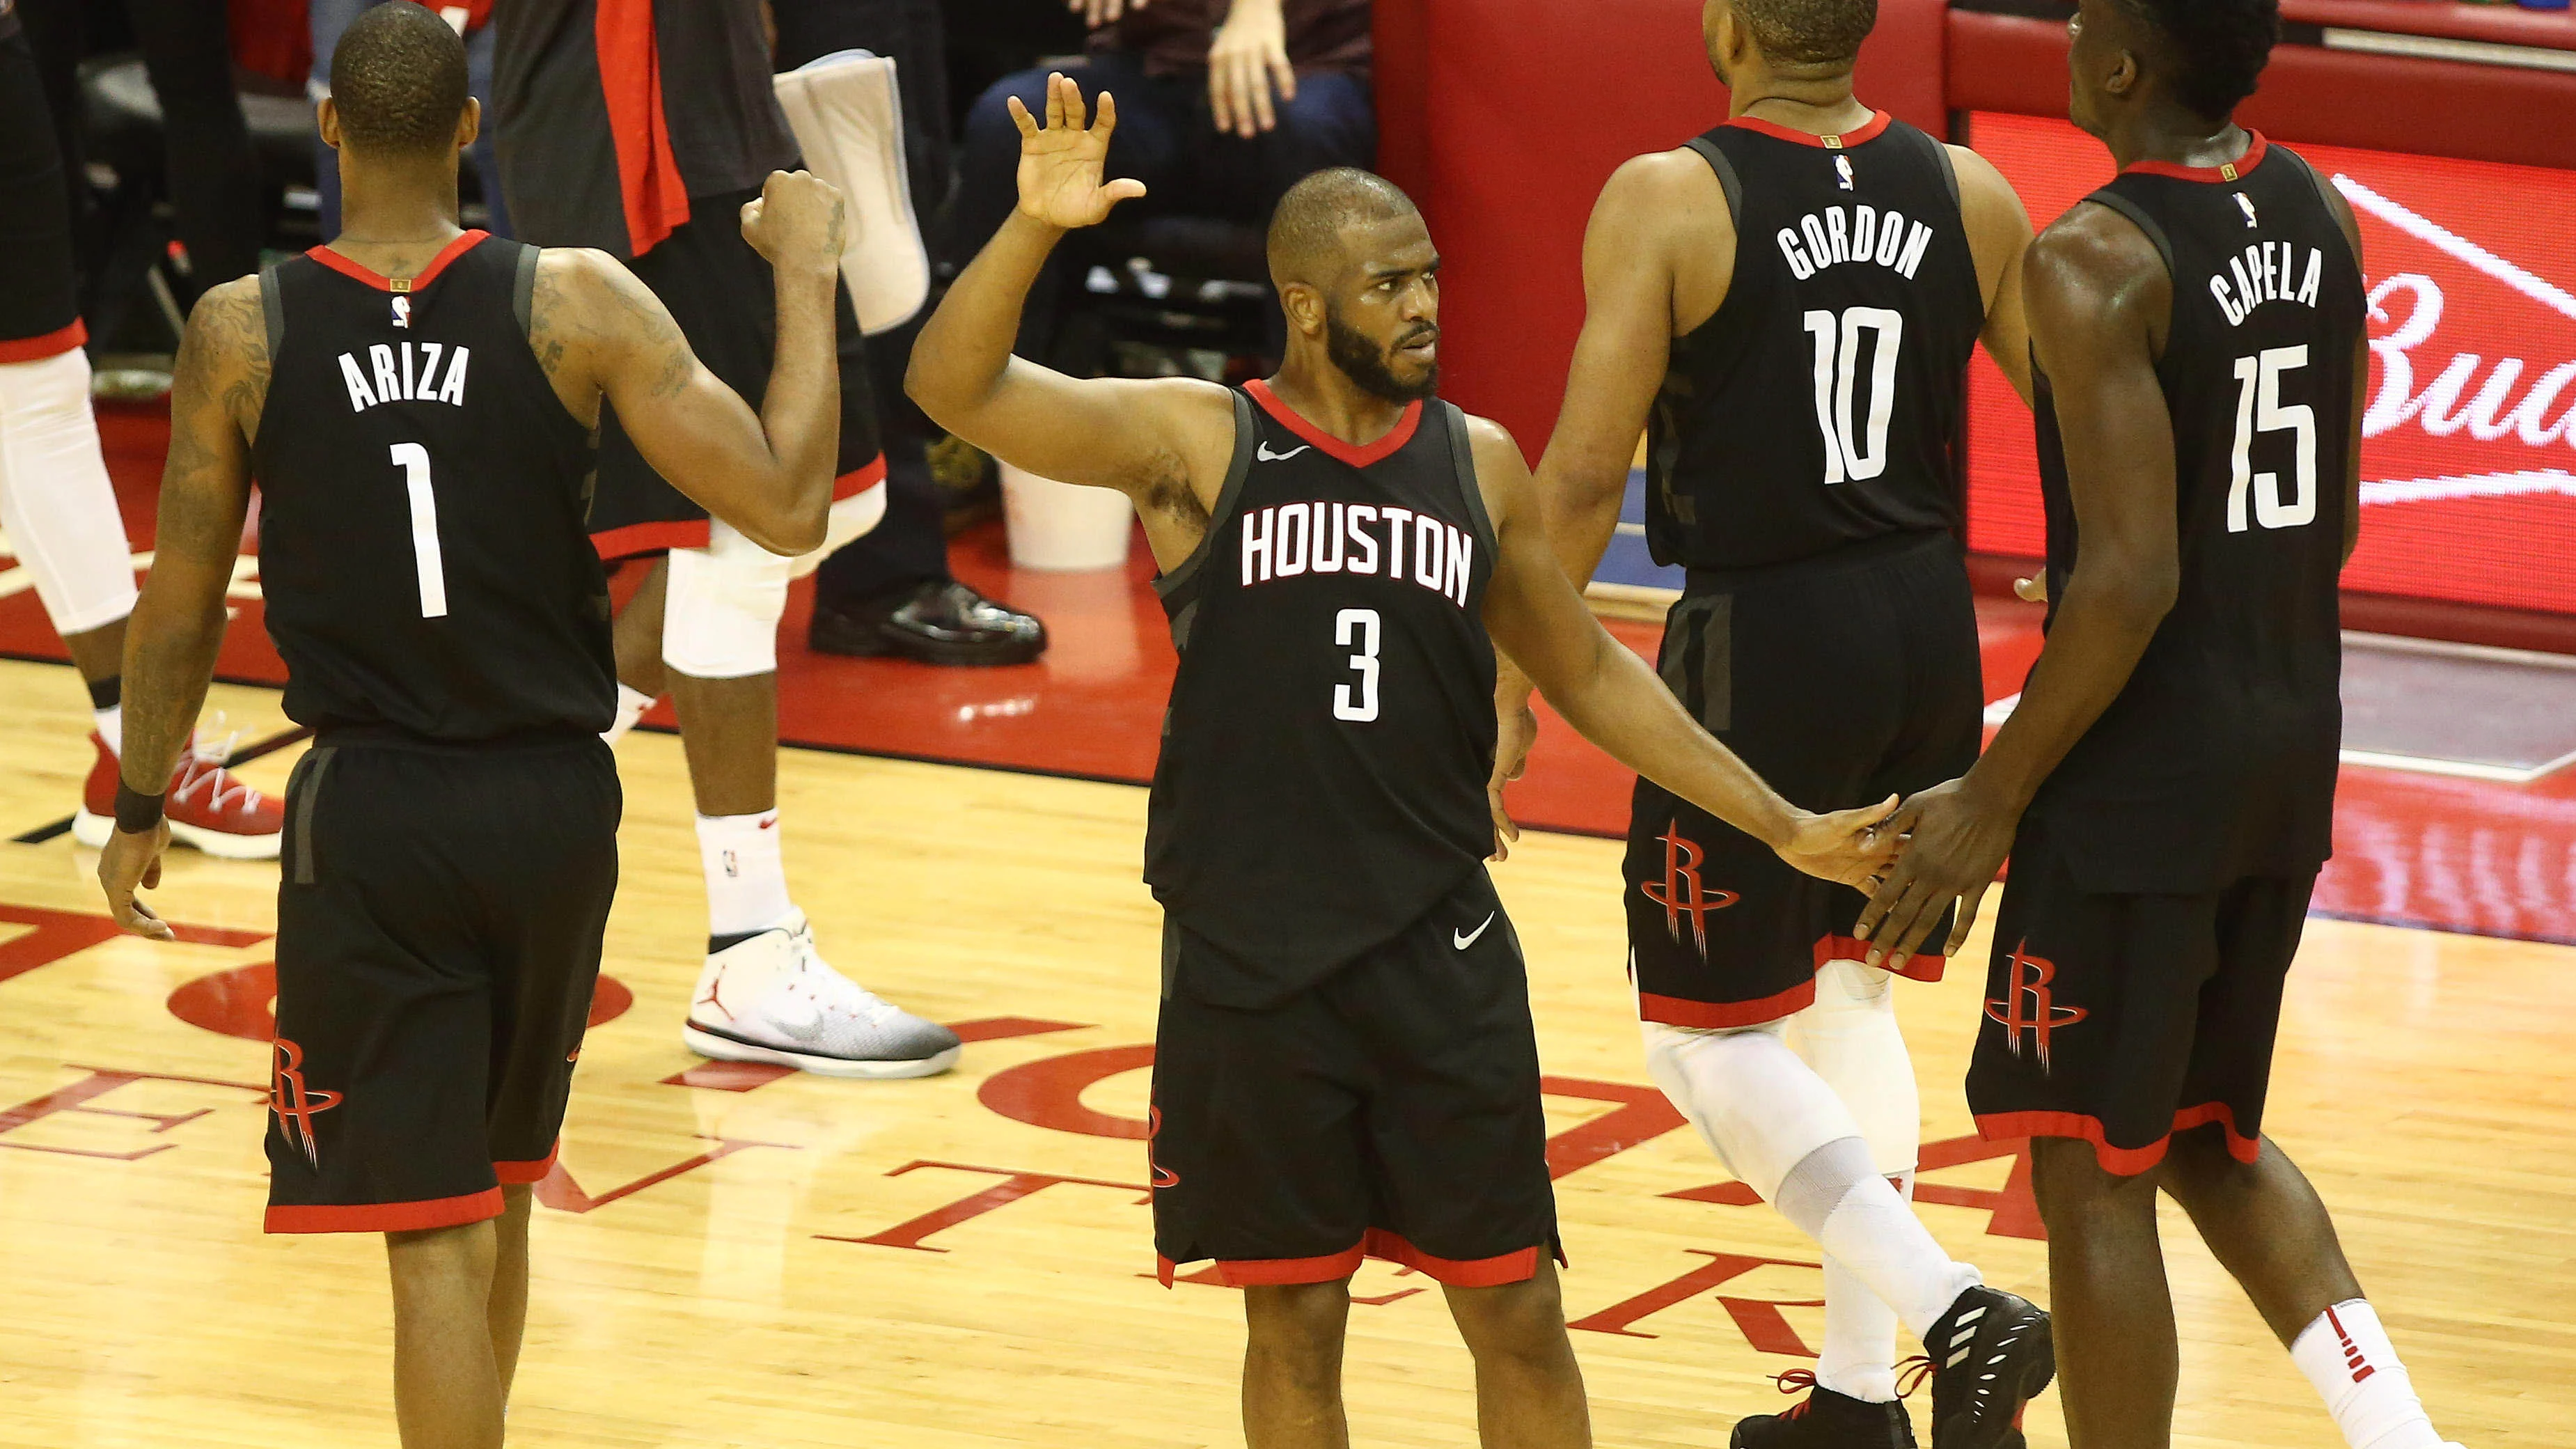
[{"x1": 1623, "y1": 533, "x2": 1986, "y2": 1028}]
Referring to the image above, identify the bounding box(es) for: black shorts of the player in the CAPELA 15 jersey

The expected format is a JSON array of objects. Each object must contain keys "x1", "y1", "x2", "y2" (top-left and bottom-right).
[{"x1": 1968, "y1": 820, "x2": 2316, "y2": 1175}]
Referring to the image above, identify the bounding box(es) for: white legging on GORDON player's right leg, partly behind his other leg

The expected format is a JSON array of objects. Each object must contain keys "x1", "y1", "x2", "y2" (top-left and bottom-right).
[{"x1": 1788, "y1": 962, "x2": 1922, "y2": 1402}]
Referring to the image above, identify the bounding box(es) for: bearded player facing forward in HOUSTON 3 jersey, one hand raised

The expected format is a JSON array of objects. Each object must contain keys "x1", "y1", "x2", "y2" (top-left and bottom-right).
[{"x1": 909, "y1": 77, "x2": 1878, "y2": 1449}]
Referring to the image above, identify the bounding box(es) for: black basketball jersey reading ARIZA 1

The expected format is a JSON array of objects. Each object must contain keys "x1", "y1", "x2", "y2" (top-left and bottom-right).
[{"x1": 253, "y1": 232, "x2": 615, "y2": 742}]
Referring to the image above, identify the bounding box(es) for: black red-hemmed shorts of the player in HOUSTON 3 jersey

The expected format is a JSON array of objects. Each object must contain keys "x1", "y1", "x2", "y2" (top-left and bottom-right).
[{"x1": 1149, "y1": 869, "x2": 1556, "y2": 1287}]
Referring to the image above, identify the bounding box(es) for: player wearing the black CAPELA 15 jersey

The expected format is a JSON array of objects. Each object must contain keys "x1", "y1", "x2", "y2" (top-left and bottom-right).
[{"x1": 1862, "y1": 0, "x2": 2442, "y2": 1449}]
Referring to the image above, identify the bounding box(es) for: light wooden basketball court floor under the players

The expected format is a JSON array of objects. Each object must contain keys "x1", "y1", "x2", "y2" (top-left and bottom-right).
[{"x1": 0, "y1": 663, "x2": 2576, "y2": 1449}]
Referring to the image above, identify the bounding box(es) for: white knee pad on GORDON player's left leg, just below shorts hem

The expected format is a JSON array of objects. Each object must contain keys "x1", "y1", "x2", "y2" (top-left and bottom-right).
[{"x1": 1644, "y1": 1021, "x2": 1860, "y2": 1202}]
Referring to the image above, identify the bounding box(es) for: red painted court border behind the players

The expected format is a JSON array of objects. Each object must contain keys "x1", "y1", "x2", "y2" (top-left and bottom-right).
[{"x1": 0, "y1": 394, "x2": 2576, "y2": 941}]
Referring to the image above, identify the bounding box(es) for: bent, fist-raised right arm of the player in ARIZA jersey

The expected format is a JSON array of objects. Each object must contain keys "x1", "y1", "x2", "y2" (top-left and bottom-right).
[{"x1": 528, "y1": 170, "x2": 842, "y2": 557}]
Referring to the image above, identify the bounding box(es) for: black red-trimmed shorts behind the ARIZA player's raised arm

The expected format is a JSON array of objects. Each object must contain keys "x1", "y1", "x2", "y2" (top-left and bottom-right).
[{"x1": 590, "y1": 188, "x2": 886, "y2": 562}]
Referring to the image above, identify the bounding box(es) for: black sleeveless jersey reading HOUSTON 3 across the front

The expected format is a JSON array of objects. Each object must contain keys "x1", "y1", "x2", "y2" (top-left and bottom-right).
[{"x1": 1144, "y1": 382, "x2": 1494, "y2": 1005}]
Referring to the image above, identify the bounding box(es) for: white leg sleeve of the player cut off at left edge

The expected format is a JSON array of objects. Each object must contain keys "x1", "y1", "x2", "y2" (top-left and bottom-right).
[{"x1": 0, "y1": 348, "x2": 134, "y2": 634}]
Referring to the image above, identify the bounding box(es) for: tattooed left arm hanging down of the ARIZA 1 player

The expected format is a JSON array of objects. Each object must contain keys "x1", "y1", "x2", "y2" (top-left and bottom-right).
[{"x1": 98, "y1": 276, "x2": 268, "y2": 941}]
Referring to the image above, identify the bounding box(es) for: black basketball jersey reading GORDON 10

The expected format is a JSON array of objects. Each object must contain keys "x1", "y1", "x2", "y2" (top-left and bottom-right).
[{"x1": 1646, "y1": 111, "x2": 1986, "y2": 570}]
